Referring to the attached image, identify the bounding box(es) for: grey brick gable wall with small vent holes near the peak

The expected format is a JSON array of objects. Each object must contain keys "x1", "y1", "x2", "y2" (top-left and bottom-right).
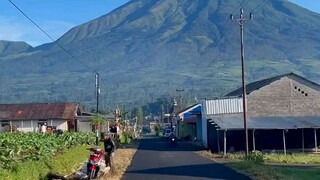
[{"x1": 247, "y1": 77, "x2": 320, "y2": 116}]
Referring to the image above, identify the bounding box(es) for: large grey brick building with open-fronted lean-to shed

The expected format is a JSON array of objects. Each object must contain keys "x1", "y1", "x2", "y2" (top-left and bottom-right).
[{"x1": 202, "y1": 73, "x2": 320, "y2": 152}]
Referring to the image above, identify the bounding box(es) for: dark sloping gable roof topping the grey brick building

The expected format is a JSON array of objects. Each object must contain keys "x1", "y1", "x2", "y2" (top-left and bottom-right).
[{"x1": 225, "y1": 73, "x2": 320, "y2": 96}]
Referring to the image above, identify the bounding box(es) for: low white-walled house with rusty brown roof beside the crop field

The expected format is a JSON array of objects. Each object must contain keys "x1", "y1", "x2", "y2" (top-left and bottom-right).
[{"x1": 0, "y1": 103, "x2": 81, "y2": 132}]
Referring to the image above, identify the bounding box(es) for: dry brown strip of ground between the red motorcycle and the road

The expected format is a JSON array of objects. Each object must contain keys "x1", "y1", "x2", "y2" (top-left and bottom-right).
[{"x1": 100, "y1": 144, "x2": 138, "y2": 180}]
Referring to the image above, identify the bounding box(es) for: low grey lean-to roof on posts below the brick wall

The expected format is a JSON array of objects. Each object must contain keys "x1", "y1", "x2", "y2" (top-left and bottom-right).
[{"x1": 208, "y1": 113, "x2": 320, "y2": 130}]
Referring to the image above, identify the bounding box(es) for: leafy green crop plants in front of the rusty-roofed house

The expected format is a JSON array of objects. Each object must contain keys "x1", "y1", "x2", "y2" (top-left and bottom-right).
[{"x1": 0, "y1": 133, "x2": 94, "y2": 170}]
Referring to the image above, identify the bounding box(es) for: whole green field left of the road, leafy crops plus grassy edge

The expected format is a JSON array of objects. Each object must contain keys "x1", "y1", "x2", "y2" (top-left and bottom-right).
[{"x1": 0, "y1": 133, "x2": 95, "y2": 179}]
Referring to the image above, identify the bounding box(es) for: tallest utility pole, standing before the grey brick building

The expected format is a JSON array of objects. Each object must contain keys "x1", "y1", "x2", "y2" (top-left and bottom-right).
[{"x1": 230, "y1": 8, "x2": 253, "y2": 155}]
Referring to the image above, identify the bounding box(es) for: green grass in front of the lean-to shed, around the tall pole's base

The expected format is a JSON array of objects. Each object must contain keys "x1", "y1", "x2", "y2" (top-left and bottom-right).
[{"x1": 226, "y1": 152, "x2": 320, "y2": 179}]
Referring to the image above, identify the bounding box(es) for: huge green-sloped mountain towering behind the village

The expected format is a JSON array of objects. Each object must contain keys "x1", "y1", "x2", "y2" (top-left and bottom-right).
[{"x1": 0, "y1": 0, "x2": 320, "y2": 112}]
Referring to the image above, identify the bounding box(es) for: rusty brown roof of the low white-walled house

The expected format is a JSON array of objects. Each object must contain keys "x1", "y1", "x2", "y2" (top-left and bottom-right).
[{"x1": 0, "y1": 103, "x2": 79, "y2": 120}]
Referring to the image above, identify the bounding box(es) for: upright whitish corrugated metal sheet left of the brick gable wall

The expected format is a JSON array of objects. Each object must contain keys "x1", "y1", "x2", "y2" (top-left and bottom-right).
[{"x1": 205, "y1": 98, "x2": 243, "y2": 115}]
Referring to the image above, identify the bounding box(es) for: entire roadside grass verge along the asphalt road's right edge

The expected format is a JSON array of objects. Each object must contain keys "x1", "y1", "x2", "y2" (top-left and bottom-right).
[{"x1": 198, "y1": 151, "x2": 320, "y2": 180}]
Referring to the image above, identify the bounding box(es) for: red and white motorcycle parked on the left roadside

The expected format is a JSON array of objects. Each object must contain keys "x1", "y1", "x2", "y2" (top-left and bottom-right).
[{"x1": 87, "y1": 147, "x2": 105, "y2": 180}]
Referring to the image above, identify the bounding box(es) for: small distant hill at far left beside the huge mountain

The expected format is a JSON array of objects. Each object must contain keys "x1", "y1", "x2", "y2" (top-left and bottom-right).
[{"x1": 0, "y1": 40, "x2": 33, "y2": 56}]
